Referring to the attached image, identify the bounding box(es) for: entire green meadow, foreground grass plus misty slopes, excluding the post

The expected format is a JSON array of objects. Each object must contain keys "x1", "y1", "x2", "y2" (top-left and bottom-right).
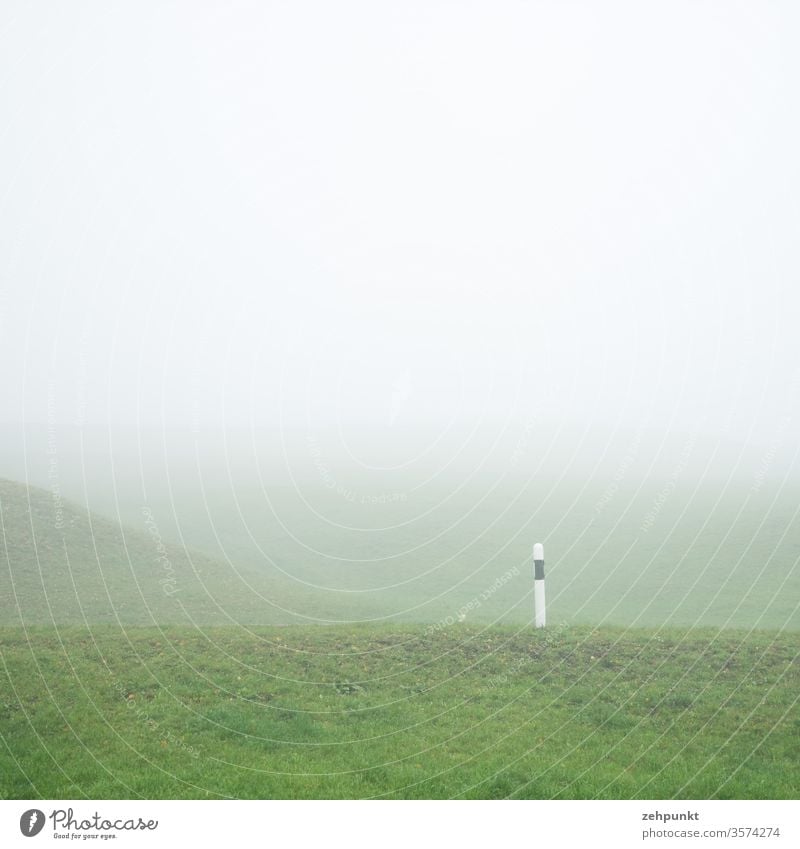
[{"x1": 0, "y1": 444, "x2": 800, "y2": 799}]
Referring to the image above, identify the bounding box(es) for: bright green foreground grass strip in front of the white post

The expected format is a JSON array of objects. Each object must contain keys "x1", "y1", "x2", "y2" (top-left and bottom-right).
[{"x1": 0, "y1": 625, "x2": 800, "y2": 799}]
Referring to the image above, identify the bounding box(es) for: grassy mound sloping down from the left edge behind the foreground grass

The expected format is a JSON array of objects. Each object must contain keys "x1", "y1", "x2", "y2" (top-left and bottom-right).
[{"x1": 0, "y1": 480, "x2": 304, "y2": 625}]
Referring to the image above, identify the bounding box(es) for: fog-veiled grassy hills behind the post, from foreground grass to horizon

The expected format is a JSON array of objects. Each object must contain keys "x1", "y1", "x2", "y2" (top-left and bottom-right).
[{"x1": 0, "y1": 422, "x2": 800, "y2": 630}]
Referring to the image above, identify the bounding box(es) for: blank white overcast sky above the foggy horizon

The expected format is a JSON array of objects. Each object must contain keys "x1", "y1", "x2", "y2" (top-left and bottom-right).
[{"x1": 0, "y1": 0, "x2": 800, "y2": 458}]
